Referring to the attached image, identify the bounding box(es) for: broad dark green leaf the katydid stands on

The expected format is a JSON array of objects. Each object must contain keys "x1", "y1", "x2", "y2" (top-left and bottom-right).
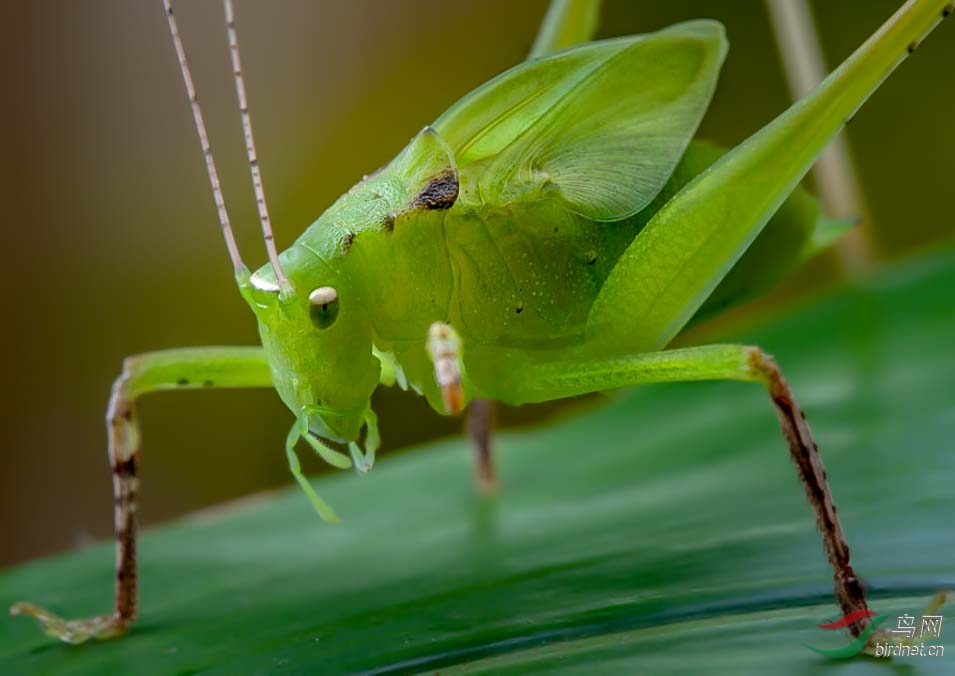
[{"x1": 0, "y1": 247, "x2": 955, "y2": 674}]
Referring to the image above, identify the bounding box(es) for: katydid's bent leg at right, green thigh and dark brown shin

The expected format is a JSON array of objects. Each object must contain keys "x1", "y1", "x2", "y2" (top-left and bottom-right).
[{"x1": 509, "y1": 345, "x2": 869, "y2": 637}]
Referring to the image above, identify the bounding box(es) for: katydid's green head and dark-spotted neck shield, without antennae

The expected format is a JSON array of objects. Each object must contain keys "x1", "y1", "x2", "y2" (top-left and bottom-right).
[{"x1": 240, "y1": 127, "x2": 458, "y2": 450}]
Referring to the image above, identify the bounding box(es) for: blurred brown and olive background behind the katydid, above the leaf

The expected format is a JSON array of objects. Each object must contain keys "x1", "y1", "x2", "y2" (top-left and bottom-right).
[{"x1": 0, "y1": 0, "x2": 955, "y2": 566}]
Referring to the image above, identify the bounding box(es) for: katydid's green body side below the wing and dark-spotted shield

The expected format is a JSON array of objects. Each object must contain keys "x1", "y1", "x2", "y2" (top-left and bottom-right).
[{"x1": 326, "y1": 193, "x2": 636, "y2": 400}]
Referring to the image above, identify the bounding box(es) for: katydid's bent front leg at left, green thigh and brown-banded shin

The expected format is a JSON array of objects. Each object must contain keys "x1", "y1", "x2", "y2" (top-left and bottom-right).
[{"x1": 10, "y1": 347, "x2": 272, "y2": 644}]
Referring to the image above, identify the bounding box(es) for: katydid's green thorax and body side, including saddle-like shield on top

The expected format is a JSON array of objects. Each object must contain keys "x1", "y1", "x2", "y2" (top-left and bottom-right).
[{"x1": 250, "y1": 124, "x2": 639, "y2": 412}]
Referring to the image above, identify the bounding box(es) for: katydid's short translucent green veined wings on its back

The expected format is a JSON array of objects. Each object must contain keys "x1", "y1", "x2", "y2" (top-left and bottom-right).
[{"x1": 434, "y1": 21, "x2": 726, "y2": 221}]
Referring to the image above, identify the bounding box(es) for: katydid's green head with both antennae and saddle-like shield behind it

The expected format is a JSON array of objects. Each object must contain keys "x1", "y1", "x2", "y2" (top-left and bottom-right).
[{"x1": 164, "y1": 0, "x2": 458, "y2": 476}]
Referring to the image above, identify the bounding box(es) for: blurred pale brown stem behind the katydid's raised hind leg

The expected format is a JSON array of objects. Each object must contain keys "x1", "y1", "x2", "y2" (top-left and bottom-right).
[{"x1": 766, "y1": 0, "x2": 874, "y2": 276}]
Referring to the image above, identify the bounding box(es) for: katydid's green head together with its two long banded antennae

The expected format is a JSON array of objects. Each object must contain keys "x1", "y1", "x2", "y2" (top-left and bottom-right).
[{"x1": 163, "y1": 0, "x2": 380, "y2": 467}]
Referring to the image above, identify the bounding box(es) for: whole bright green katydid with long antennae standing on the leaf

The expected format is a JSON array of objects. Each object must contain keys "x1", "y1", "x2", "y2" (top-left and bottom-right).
[{"x1": 13, "y1": 0, "x2": 952, "y2": 643}]
